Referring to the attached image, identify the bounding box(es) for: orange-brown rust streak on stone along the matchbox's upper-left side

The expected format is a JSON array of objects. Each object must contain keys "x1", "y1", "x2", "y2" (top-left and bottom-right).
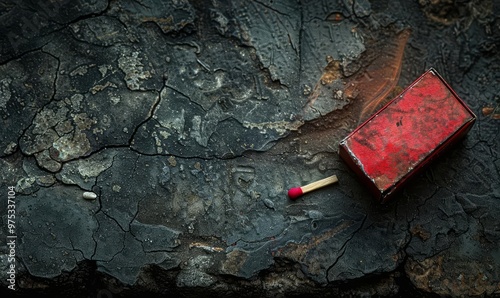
[{"x1": 274, "y1": 29, "x2": 411, "y2": 154}]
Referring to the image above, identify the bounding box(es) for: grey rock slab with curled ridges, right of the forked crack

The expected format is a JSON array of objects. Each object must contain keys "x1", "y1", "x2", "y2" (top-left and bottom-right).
[{"x1": 133, "y1": 40, "x2": 302, "y2": 157}]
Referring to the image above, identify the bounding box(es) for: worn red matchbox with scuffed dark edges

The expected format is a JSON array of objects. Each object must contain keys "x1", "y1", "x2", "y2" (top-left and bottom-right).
[{"x1": 339, "y1": 68, "x2": 476, "y2": 203}]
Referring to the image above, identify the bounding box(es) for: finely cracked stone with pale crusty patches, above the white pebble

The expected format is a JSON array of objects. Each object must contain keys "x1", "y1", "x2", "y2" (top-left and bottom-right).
[{"x1": 20, "y1": 41, "x2": 157, "y2": 172}]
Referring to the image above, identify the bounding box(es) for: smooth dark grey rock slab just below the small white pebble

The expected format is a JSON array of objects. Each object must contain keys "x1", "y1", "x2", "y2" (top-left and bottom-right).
[{"x1": 13, "y1": 148, "x2": 185, "y2": 284}]
